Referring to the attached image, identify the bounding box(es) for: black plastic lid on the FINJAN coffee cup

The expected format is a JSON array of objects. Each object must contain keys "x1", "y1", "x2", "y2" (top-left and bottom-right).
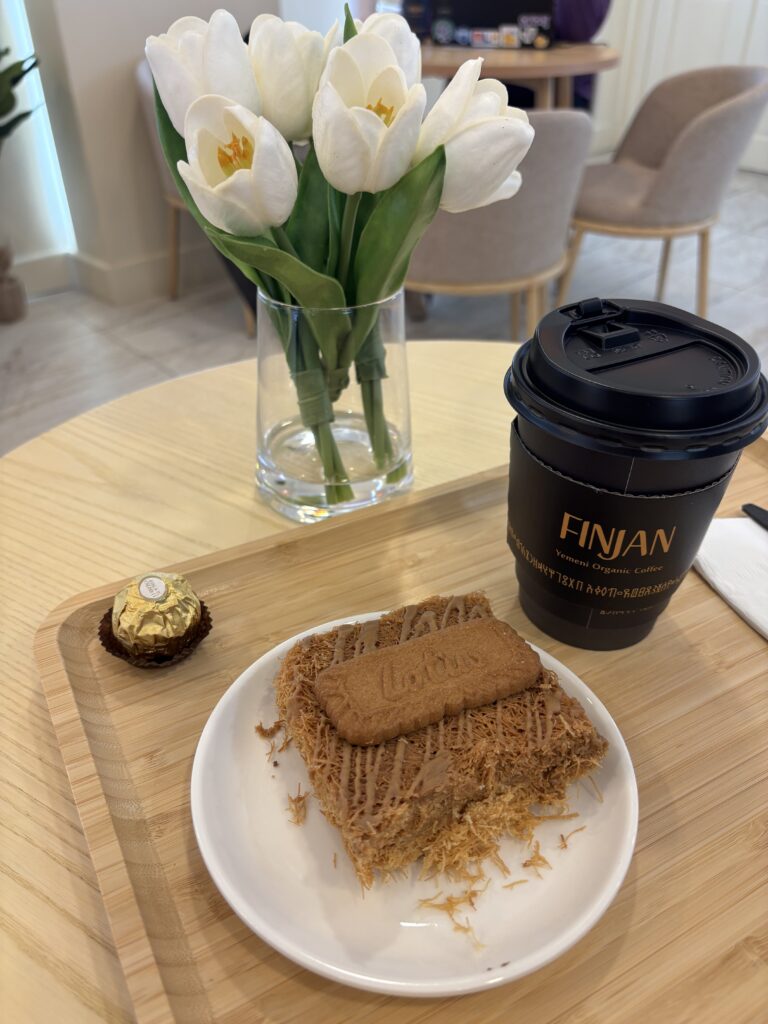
[{"x1": 505, "y1": 299, "x2": 768, "y2": 459}]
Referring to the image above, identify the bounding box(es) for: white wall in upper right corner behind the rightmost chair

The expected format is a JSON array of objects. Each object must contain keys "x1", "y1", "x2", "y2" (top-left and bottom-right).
[{"x1": 593, "y1": 0, "x2": 768, "y2": 173}]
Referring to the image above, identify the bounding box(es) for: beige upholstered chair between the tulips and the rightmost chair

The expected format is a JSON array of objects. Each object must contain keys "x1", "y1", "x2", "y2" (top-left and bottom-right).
[{"x1": 406, "y1": 111, "x2": 592, "y2": 339}]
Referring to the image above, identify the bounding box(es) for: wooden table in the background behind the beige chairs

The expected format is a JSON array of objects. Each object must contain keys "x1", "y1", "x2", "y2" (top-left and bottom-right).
[{"x1": 421, "y1": 43, "x2": 621, "y2": 110}]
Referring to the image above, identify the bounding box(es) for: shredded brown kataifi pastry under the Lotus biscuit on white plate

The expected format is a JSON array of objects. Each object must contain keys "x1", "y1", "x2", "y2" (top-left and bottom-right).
[{"x1": 274, "y1": 593, "x2": 607, "y2": 886}]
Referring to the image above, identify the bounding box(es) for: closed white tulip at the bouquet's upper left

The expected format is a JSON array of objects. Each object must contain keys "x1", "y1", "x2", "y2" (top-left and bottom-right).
[{"x1": 145, "y1": 10, "x2": 260, "y2": 135}]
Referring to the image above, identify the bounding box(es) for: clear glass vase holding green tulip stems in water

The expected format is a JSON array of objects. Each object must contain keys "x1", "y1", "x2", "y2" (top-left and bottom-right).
[{"x1": 256, "y1": 291, "x2": 413, "y2": 522}]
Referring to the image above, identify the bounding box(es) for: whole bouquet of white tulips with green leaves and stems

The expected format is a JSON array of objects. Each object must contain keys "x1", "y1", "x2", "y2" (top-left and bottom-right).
[{"x1": 146, "y1": 6, "x2": 534, "y2": 504}]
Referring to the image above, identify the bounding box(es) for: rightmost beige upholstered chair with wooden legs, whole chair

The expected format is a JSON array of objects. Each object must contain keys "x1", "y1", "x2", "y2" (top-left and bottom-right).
[{"x1": 558, "y1": 67, "x2": 768, "y2": 316}]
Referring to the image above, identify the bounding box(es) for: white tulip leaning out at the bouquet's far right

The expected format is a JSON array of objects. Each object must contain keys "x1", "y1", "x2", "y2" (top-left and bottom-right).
[{"x1": 414, "y1": 57, "x2": 534, "y2": 213}]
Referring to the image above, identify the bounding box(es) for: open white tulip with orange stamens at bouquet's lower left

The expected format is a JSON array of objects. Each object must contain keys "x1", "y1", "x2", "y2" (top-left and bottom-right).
[{"x1": 178, "y1": 96, "x2": 298, "y2": 236}]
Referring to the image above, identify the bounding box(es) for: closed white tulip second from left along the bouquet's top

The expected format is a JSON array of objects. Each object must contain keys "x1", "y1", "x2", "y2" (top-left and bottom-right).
[{"x1": 248, "y1": 14, "x2": 341, "y2": 142}]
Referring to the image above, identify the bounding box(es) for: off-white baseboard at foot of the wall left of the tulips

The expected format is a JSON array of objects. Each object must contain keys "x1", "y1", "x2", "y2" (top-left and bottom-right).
[{"x1": 74, "y1": 242, "x2": 224, "y2": 305}]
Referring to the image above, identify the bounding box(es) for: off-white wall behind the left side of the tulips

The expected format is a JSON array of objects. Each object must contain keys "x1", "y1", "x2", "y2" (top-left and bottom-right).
[{"x1": 28, "y1": 0, "x2": 278, "y2": 303}]
